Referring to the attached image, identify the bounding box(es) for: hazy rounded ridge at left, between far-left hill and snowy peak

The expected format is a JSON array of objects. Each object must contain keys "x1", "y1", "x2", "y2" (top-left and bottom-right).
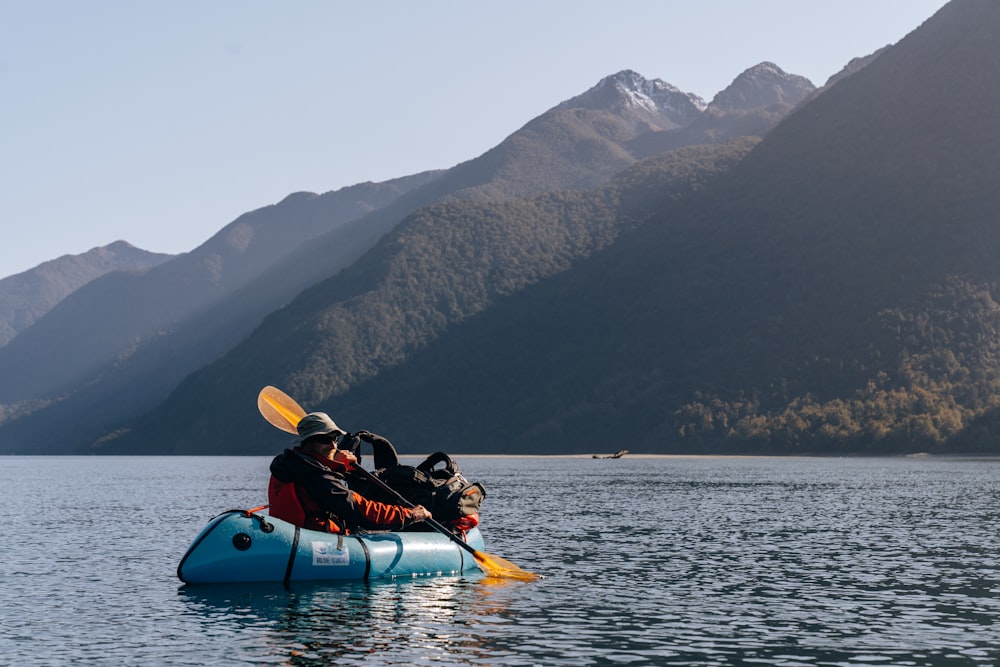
[{"x1": 0, "y1": 173, "x2": 436, "y2": 434}]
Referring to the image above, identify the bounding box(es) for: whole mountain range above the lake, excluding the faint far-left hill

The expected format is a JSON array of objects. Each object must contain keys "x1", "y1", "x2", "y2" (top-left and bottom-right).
[{"x1": 0, "y1": 0, "x2": 1000, "y2": 454}]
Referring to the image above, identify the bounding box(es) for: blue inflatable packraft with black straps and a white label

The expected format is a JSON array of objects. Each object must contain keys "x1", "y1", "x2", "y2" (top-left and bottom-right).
[{"x1": 177, "y1": 510, "x2": 483, "y2": 584}]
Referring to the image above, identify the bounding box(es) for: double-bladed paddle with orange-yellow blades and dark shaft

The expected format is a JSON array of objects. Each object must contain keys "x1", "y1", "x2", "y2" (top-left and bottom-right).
[{"x1": 257, "y1": 386, "x2": 539, "y2": 581}]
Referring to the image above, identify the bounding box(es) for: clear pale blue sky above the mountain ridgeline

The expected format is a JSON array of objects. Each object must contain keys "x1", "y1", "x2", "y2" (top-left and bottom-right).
[{"x1": 0, "y1": 0, "x2": 945, "y2": 277}]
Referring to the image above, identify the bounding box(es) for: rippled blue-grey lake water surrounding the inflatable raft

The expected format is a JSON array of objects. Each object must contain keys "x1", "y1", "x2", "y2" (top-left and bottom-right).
[{"x1": 0, "y1": 456, "x2": 1000, "y2": 667}]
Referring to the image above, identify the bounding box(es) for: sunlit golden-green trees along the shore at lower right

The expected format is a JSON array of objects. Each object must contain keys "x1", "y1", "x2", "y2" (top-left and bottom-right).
[{"x1": 677, "y1": 280, "x2": 1000, "y2": 454}]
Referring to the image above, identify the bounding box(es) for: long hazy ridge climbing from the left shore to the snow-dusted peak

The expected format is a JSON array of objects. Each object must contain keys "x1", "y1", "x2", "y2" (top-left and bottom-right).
[{"x1": 0, "y1": 45, "x2": 812, "y2": 451}]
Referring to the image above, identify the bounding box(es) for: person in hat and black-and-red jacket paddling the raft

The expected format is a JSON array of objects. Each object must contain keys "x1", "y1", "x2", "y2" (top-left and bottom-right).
[{"x1": 267, "y1": 412, "x2": 432, "y2": 533}]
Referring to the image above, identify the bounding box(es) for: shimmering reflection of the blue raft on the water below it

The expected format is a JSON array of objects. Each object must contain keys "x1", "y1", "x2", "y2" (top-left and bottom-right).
[{"x1": 179, "y1": 575, "x2": 525, "y2": 665}]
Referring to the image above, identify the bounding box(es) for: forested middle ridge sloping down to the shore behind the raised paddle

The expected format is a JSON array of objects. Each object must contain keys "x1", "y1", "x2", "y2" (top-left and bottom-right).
[{"x1": 99, "y1": 139, "x2": 754, "y2": 453}]
